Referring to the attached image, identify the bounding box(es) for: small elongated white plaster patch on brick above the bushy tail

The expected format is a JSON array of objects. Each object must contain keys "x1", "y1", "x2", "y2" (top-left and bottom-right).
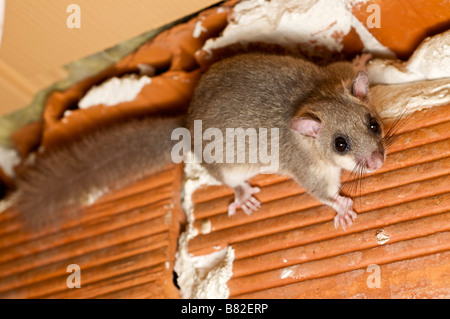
[{"x1": 78, "y1": 74, "x2": 152, "y2": 109}]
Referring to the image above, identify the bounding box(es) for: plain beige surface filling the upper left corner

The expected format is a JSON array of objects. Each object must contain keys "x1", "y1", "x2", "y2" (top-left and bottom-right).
[{"x1": 0, "y1": 0, "x2": 219, "y2": 116}]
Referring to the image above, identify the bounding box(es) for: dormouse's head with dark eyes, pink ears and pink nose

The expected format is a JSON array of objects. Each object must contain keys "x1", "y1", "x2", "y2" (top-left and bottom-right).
[{"x1": 290, "y1": 71, "x2": 385, "y2": 172}]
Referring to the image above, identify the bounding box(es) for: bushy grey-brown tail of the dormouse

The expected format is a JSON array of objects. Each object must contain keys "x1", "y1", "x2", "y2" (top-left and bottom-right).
[{"x1": 15, "y1": 118, "x2": 183, "y2": 230}]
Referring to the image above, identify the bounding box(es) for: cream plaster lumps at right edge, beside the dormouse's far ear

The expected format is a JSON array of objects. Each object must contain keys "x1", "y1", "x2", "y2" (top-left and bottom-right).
[{"x1": 368, "y1": 30, "x2": 450, "y2": 118}]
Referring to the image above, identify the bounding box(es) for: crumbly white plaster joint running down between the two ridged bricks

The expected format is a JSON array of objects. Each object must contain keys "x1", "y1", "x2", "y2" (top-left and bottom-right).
[{"x1": 174, "y1": 153, "x2": 234, "y2": 299}]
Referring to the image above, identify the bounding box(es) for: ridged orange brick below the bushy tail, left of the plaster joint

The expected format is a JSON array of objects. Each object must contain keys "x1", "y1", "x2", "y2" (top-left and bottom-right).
[{"x1": 0, "y1": 166, "x2": 184, "y2": 298}]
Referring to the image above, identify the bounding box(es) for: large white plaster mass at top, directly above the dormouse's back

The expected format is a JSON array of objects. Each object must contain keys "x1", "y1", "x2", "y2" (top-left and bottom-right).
[{"x1": 203, "y1": 0, "x2": 394, "y2": 56}]
